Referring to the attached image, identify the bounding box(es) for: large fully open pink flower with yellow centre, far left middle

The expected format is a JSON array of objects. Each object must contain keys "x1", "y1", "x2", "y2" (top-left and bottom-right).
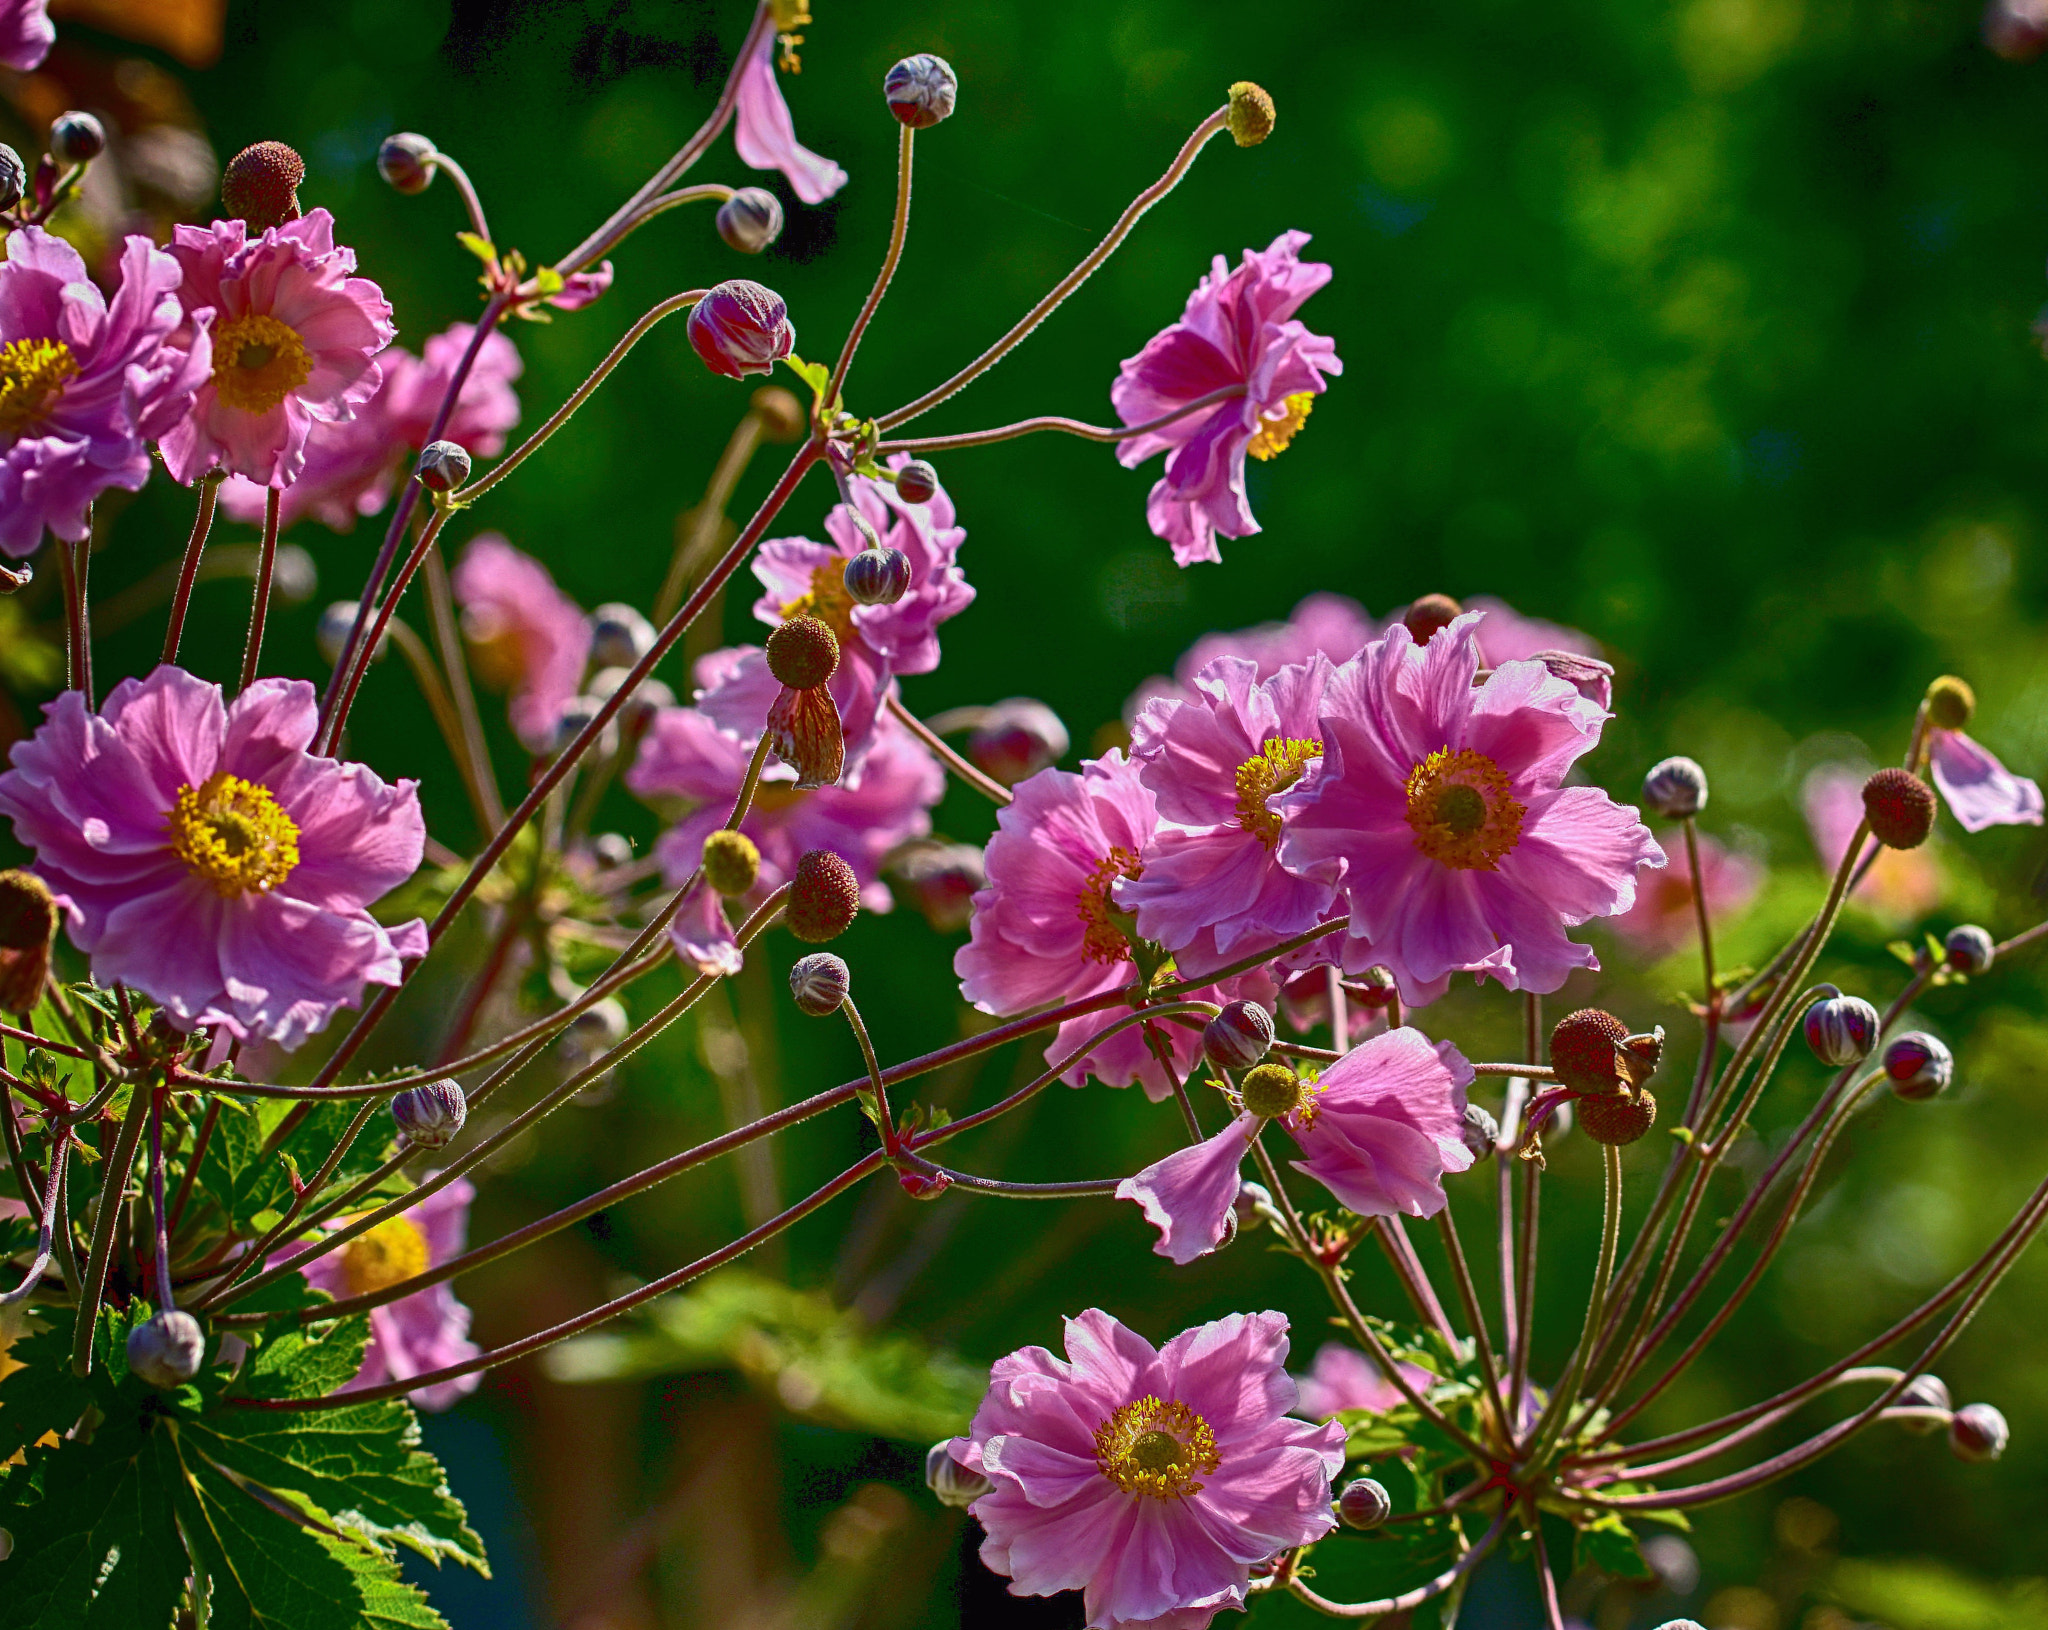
[{"x1": 0, "y1": 668, "x2": 426, "y2": 1046}]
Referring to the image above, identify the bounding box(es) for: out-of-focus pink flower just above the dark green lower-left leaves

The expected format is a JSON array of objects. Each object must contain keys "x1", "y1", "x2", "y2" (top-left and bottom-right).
[{"x1": 301, "y1": 1177, "x2": 483, "y2": 1409}]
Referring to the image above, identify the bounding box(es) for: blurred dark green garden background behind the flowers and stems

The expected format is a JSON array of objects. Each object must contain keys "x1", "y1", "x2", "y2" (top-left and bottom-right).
[{"x1": 0, "y1": 0, "x2": 2048, "y2": 1630}]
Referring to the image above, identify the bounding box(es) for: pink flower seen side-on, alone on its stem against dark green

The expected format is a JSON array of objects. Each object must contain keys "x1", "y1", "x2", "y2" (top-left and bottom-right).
[{"x1": 1110, "y1": 231, "x2": 1343, "y2": 565}]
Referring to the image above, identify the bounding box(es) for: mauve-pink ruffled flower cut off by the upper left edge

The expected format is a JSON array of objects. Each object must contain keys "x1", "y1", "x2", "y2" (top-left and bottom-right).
[{"x1": 0, "y1": 227, "x2": 213, "y2": 559}]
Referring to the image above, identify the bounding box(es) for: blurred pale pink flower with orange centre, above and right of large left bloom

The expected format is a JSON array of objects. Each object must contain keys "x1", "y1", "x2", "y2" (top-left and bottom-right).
[{"x1": 451, "y1": 532, "x2": 592, "y2": 754}]
